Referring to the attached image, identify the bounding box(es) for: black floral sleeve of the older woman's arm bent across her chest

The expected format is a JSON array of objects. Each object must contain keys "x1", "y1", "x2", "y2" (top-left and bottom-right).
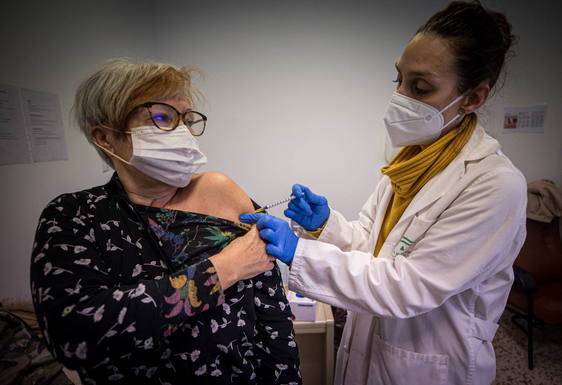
[{"x1": 31, "y1": 195, "x2": 224, "y2": 368}]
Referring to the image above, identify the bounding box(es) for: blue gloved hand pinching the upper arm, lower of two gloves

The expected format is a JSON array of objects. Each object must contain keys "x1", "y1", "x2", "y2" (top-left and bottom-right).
[{"x1": 240, "y1": 214, "x2": 299, "y2": 265}]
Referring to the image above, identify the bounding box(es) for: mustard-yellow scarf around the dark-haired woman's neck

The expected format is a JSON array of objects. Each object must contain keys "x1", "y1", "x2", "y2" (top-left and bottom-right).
[{"x1": 373, "y1": 114, "x2": 478, "y2": 257}]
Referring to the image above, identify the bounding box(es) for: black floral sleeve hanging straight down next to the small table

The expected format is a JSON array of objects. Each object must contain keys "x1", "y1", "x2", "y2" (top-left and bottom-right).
[{"x1": 253, "y1": 264, "x2": 302, "y2": 384}]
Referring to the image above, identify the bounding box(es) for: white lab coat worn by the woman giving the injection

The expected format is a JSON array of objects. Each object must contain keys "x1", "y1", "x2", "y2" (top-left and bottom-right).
[{"x1": 289, "y1": 126, "x2": 527, "y2": 385}]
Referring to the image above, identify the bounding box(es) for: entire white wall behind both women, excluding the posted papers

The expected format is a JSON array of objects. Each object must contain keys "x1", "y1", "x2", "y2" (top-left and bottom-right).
[{"x1": 0, "y1": 0, "x2": 562, "y2": 297}]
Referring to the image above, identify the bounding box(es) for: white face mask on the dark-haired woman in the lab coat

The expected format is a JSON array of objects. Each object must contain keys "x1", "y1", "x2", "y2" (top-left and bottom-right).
[{"x1": 384, "y1": 91, "x2": 465, "y2": 147}]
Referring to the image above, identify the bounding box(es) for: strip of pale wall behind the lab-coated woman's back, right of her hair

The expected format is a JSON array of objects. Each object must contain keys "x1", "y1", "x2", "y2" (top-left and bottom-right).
[{"x1": 485, "y1": 0, "x2": 562, "y2": 188}]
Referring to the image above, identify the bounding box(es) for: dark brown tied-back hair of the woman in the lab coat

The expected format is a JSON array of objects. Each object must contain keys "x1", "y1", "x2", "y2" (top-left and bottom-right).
[{"x1": 416, "y1": 1, "x2": 515, "y2": 93}]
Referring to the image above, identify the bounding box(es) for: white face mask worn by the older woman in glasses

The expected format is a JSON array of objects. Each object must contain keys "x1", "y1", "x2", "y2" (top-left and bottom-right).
[{"x1": 94, "y1": 125, "x2": 207, "y2": 187}]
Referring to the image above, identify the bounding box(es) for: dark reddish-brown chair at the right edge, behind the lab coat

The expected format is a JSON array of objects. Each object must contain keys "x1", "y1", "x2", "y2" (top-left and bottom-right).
[{"x1": 508, "y1": 217, "x2": 562, "y2": 370}]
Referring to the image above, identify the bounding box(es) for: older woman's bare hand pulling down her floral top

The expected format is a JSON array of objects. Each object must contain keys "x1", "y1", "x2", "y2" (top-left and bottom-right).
[{"x1": 209, "y1": 226, "x2": 275, "y2": 290}]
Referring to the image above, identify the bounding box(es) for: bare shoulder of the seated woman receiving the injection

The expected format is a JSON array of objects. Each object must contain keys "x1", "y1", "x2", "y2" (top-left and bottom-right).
[{"x1": 197, "y1": 171, "x2": 253, "y2": 213}]
